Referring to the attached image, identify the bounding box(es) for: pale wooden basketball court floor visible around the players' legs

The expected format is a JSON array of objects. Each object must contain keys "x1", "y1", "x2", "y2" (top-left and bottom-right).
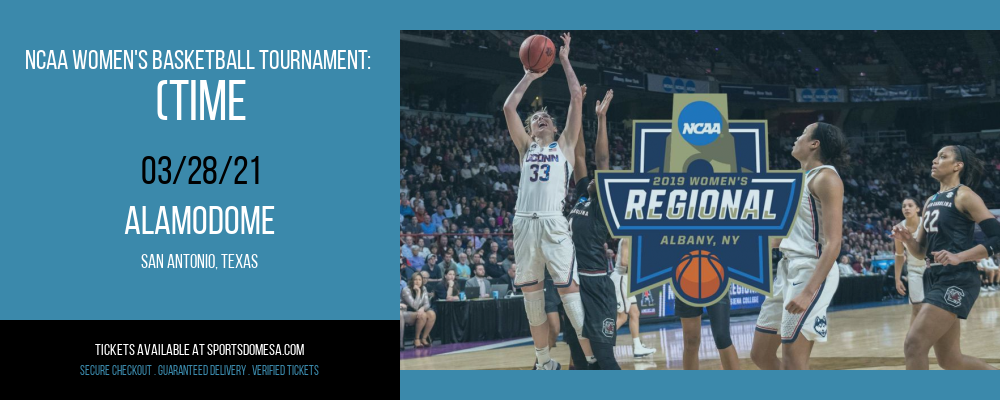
[{"x1": 399, "y1": 291, "x2": 1000, "y2": 370}]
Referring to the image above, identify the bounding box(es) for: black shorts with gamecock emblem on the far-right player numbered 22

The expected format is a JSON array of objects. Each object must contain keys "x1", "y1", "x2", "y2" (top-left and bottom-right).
[{"x1": 924, "y1": 263, "x2": 982, "y2": 319}]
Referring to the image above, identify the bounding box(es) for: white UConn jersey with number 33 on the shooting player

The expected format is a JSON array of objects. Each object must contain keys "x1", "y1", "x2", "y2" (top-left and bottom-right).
[{"x1": 515, "y1": 142, "x2": 573, "y2": 216}]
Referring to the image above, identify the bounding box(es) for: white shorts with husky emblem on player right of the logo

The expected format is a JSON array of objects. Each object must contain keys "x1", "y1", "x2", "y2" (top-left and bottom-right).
[{"x1": 757, "y1": 257, "x2": 840, "y2": 343}]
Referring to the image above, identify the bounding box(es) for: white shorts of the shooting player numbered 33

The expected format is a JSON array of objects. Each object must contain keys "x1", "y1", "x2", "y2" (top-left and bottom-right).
[{"x1": 514, "y1": 215, "x2": 577, "y2": 287}]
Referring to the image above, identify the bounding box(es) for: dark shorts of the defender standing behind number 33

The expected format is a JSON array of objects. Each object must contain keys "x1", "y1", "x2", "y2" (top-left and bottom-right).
[{"x1": 580, "y1": 275, "x2": 618, "y2": 345}]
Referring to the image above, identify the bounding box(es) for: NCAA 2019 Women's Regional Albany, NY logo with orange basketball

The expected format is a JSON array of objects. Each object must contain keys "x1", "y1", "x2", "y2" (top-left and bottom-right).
[{"x1": 597, "y1": 94, "x2": 803, "y2": 306}]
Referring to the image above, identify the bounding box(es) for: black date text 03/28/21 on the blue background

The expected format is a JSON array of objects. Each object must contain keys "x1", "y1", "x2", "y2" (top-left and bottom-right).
[{"x1": 142, "y1": 156, "x2": 260, "y2": 185}]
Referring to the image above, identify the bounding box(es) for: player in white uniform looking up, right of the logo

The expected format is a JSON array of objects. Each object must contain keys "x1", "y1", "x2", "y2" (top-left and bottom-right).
[{"x1": 750, "y1": 122, "x2": 847, "y2": 369}]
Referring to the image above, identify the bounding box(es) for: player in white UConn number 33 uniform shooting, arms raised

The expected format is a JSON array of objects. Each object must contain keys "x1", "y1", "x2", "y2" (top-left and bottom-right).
[{"x1": 503, "y1": 33, "x2": 593, "y2": 370}]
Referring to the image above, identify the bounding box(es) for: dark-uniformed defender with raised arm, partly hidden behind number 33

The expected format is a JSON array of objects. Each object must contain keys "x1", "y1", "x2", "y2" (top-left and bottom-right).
[{"x1": 568, "y1": 90, "x2": 621, "y2": 370}]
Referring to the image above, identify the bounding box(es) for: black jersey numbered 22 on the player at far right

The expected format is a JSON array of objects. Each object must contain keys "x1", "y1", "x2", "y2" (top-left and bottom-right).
[{"x1": 923, "y1": 185, "x2": 976, "y2": 263}]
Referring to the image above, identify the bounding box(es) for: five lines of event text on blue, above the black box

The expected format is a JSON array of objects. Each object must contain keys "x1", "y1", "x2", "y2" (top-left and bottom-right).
[{"x1": 25, "y1": 49, "x2": 371, "y2": 270}]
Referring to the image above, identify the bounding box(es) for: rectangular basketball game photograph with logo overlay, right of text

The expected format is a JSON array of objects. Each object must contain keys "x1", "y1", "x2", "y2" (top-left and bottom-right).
[{"x1": 399, "y1": 30, "x2": 1000, "y2": 371}]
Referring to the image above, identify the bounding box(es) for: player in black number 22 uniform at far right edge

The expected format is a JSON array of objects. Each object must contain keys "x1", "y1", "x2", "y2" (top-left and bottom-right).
[{"x1": 893, "y1": 146, "x2": 1000, "y2": 369}]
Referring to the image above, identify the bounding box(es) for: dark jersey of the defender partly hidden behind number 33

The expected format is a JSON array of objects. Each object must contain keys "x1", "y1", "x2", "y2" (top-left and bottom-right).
[{"x1": 568, "y1": 178, "x2": 610, "y2": 273}]
